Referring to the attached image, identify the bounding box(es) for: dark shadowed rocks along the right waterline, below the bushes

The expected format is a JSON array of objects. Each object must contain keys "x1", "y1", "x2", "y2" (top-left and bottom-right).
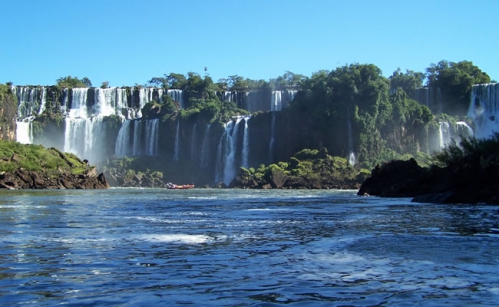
[{"x1": 358, "y1": 159, "x2": 499, "y2": 204}]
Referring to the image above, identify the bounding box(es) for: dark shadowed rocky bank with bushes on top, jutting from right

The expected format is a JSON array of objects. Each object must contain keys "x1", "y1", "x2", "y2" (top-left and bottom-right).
[{"x1": 358, "y1": 133, "x2": 499, "y2": 204}]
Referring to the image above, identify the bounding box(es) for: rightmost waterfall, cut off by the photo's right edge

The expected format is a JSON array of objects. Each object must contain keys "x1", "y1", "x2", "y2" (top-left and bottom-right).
[{"x1": 468, "y1": 83, "x2": 499, "y2": 138}]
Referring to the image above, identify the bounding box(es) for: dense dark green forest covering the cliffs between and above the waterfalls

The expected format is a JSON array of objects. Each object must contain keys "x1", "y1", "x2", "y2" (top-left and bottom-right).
[{"x1": 0, "y1": 60, "x2": 491, "y2": 186}]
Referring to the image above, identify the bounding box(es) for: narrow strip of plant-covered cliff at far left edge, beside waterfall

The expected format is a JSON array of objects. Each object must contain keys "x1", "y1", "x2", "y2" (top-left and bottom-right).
[{"x1": 0, "y1": 84, "x2": 17, "y2": 141}]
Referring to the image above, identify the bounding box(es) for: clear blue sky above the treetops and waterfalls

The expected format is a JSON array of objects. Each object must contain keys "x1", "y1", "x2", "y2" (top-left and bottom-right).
[{"x1": 0, "y1": 0, "x2": 499, "y2": 86}]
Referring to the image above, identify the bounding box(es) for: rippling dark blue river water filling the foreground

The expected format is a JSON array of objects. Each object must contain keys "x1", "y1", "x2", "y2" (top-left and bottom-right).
[{"x1": 0, "y1": 189, "x2": 499, "y2": 306}]
